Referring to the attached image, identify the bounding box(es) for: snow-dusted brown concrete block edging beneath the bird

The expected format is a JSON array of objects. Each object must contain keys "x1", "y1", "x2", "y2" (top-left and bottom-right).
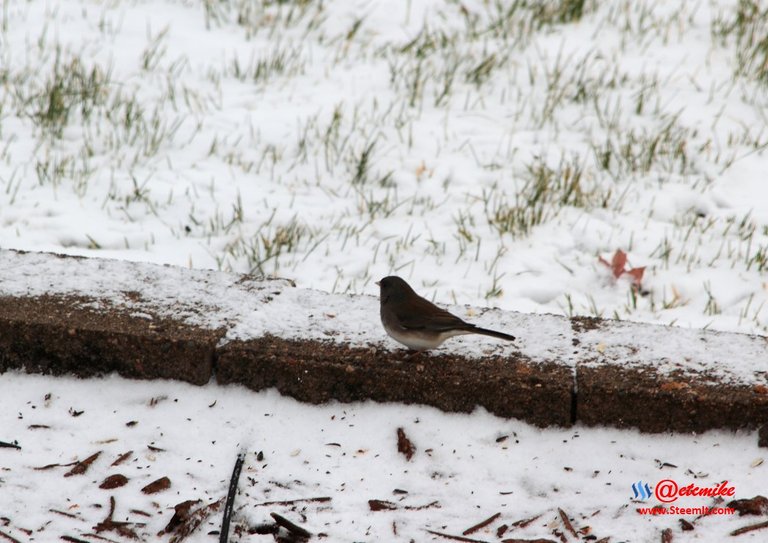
[{"x1": 0, "y1": 251, "x2": 768, "y2": 432}]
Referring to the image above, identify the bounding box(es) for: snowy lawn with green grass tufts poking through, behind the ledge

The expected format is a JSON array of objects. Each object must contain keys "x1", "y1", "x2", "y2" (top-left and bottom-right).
[{"x1": 0, "y1": 0, "x2": 768, "y2": 333}]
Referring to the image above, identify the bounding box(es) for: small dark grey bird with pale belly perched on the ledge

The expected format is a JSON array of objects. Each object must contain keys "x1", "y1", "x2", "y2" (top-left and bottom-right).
[{"x1": 376, "y1": 275, "x2": 515, "y2": 351}]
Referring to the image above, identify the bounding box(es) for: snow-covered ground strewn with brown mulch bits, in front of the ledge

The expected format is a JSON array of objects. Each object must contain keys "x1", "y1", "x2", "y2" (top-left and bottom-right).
[{"x1": 0, "y1": 373, "x2": 766, "y2": 542}]
